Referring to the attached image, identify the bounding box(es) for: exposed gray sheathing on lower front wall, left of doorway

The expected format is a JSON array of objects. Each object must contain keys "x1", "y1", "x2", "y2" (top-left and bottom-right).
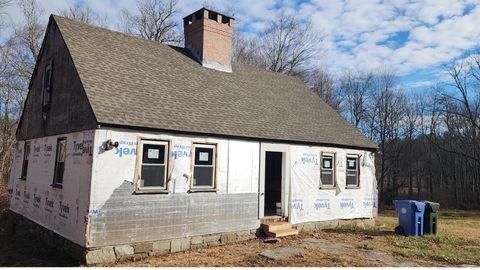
[{"x1": 87, "y1": 181, "x2": 260, "y2": 248}]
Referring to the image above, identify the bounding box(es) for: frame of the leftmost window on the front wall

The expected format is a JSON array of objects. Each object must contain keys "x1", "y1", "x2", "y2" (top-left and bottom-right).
[{"x1": 137, "y1": 139, "x2": 170, "y2": 191}]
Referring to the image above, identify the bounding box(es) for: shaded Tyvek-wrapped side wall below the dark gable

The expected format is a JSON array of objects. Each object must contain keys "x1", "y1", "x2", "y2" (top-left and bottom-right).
[{"x1": 8, "y1": 130, "x2": 94, "y2": 246}]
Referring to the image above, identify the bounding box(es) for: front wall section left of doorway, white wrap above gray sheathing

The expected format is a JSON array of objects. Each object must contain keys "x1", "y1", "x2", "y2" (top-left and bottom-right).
[{"x1": 87, "y1": 129, "x2": 260, "y2": 247}]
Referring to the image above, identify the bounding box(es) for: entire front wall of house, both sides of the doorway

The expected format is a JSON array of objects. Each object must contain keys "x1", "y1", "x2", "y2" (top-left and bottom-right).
[{"x1": 87, "y1": 129, "x2": 377, "y2": 248}]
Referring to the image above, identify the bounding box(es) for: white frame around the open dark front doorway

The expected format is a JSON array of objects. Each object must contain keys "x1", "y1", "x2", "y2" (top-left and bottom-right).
[{"x1": 258, "y1": 143, "x2": 291, "y2": 219}]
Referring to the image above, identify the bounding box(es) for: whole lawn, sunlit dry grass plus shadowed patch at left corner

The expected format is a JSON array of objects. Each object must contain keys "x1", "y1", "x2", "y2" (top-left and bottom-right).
[{"x1": 0, "y1": 185, "x2": 480, "y2": 267}]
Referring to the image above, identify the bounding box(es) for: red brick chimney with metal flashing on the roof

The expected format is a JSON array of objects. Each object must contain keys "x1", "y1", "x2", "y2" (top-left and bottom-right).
[{"x1": 183, "y1": 8, "x2": 234, "y2": 72}]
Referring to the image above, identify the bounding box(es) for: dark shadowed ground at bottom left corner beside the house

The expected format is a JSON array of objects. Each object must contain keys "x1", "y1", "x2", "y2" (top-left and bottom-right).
[{"x1": 0, "y1": 209, "x2": 80, "y2": 267}]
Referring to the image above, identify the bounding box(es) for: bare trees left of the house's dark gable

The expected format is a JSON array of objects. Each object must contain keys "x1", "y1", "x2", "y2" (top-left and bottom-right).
[{"x1": 0, "y1": 0, "x2": 45, "y2": 184}]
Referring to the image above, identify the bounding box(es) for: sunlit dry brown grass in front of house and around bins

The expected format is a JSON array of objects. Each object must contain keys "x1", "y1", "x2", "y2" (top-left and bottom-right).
[{"x1": 109, "y1": 211, "x2": 480, "y2": 267}]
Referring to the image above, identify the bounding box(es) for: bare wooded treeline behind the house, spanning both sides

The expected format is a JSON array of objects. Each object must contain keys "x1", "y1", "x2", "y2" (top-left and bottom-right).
[{"x1": 0, "y1": 0, "x2": 480, "y2": 209}]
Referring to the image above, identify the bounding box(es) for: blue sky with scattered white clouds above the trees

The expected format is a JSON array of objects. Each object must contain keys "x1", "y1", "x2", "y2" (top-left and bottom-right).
[{"x1": 3, "y1": 0, "x2": 480, "y2": 92}]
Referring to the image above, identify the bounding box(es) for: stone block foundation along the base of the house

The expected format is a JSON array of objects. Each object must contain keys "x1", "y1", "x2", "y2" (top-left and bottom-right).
[{"x1": 7, "y1": 212, "x2": 375, "y2": 265}]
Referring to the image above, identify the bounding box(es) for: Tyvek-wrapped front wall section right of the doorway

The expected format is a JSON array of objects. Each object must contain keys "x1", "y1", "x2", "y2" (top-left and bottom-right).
[{"x1": 290, "y1": 146, "x2": 378, "y2": 224}]
